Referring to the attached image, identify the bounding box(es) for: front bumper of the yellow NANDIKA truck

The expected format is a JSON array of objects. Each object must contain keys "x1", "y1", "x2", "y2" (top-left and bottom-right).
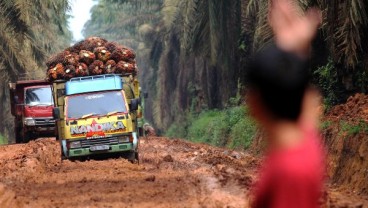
[{"x1": 68, "y1": 143, "x2": 135, "y2": 157}]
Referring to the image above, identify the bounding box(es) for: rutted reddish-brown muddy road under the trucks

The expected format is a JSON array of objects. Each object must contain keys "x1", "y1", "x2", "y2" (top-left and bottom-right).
[{"x1": 0, "y1": 137, "x2": 368, "y2": 207}]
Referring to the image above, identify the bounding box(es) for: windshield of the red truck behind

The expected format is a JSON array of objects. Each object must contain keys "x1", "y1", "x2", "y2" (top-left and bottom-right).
[{"x1": 25, "y1": 87, "x2": 53, "y2": 106}]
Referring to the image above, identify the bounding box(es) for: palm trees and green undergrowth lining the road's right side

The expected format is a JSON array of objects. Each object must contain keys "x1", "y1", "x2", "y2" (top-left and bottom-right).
[{"x1": 85, "y1": 0, "x2": 368, "y2": 150}]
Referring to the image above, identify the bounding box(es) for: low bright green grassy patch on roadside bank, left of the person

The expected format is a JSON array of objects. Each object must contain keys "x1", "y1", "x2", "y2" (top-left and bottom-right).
[{"x1": 166, "y1": 106, "x2": 256, "y2": 149}]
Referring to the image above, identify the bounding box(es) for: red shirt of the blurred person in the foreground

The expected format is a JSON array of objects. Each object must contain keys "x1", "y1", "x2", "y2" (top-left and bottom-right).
[{"x1": 253, "y1": 127, "x2": 324, "y2": 208}]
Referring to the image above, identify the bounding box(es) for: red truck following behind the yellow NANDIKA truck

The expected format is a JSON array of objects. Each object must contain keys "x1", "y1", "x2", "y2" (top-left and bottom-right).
[{"x1": 9, "y1": 80, "x2": 55, "y2": 143}]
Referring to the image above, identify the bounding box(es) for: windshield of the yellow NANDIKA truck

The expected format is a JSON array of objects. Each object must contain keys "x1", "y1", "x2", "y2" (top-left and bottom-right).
[{"x1": 66, "y1": 91, "x2": 127, "y2": 119}]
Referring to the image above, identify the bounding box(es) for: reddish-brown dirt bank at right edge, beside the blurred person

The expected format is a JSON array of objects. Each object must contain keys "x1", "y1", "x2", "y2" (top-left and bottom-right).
[{"x1": 322, "y1": 94, "x2": 368, "y2": 196}]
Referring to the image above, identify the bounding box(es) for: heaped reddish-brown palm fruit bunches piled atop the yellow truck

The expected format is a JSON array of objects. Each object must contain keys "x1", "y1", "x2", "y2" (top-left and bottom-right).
[{"x1": 46, "y1": 37, "x2": 138, "y2": 81}]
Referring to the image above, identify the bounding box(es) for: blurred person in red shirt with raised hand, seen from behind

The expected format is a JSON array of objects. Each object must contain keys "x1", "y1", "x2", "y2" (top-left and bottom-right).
[{"x1": 246, "y1": 0, "x2": 324, "y2": 208}]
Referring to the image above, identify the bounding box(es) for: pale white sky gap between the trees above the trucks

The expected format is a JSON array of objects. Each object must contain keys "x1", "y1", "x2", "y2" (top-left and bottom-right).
[{"x1": 69, "y1": 0, "x2": 97, "y2": 41}]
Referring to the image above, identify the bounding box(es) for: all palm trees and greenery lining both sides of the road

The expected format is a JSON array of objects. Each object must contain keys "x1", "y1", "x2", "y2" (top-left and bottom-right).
[{"x1": 0, "y1": 0, "x2": 368, "y2": 147}]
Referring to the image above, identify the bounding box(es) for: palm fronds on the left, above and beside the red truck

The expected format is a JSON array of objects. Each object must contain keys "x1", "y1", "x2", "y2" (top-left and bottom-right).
[{"x1": 0, "y1": 0, "x2": 71, "y2": 141}]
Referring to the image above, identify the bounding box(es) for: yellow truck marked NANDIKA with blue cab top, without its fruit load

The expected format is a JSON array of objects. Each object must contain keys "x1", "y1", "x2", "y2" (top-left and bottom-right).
[{"x1": 52, "y1": 74, "x2": 143, "y2": 162}]
